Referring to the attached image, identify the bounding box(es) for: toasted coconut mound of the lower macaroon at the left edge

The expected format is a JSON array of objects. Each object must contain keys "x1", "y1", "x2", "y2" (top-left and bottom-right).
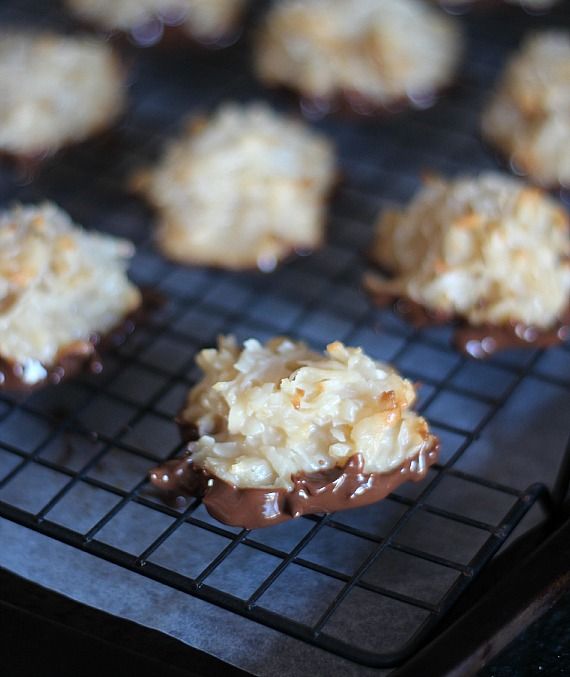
[{"x1": 0, "y1": 204, "x2": 141, "y2": 388}]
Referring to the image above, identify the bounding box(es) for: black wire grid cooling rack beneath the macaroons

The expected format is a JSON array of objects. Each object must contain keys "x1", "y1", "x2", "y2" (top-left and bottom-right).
[{"x1": 0, "y1": 2, "x2": 570, "y2": 666}]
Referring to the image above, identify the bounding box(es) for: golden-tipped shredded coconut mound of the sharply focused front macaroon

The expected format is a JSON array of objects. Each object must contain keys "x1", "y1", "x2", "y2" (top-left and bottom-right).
[{"x1": 181, "y1": 336, "x2": 435, "y2": 490}]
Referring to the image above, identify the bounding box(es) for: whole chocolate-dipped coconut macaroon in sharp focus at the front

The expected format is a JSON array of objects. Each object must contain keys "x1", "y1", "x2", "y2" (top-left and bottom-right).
[{"x1": 151, "y1": 336, "x2": 438, "y2": 528}]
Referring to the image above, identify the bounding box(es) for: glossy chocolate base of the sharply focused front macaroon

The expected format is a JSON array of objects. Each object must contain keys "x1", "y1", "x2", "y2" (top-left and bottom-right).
[{"x1": 150, "y1": 441, "x2": 439, "y2": 529}]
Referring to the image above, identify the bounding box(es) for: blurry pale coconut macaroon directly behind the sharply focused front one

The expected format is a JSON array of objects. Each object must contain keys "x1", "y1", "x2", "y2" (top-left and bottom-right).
[{"x1": 133, "y1": 104, "x2": 336, "y2": 271}]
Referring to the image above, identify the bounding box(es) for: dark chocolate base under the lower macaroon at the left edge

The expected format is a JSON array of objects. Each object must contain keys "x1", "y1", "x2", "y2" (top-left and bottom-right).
[{"x1": 0, "y1": 290, "x2": 163, "y2": 392}]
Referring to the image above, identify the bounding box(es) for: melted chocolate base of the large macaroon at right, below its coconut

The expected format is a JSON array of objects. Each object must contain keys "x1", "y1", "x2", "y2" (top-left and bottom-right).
[{"x1": 364, "y1": 291, "x2": 570, "y2": 359}]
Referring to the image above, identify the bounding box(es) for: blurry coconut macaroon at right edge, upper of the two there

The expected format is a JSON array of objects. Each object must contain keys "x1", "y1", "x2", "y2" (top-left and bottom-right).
[{"x1": 482, "y1": 30, "x2": 570, "y2": 188}]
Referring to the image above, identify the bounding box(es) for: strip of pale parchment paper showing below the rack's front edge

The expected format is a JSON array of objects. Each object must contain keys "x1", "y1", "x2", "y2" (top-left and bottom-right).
[{"x1": 0, "y1": 519, "x2": 387, "y2": 677}]
